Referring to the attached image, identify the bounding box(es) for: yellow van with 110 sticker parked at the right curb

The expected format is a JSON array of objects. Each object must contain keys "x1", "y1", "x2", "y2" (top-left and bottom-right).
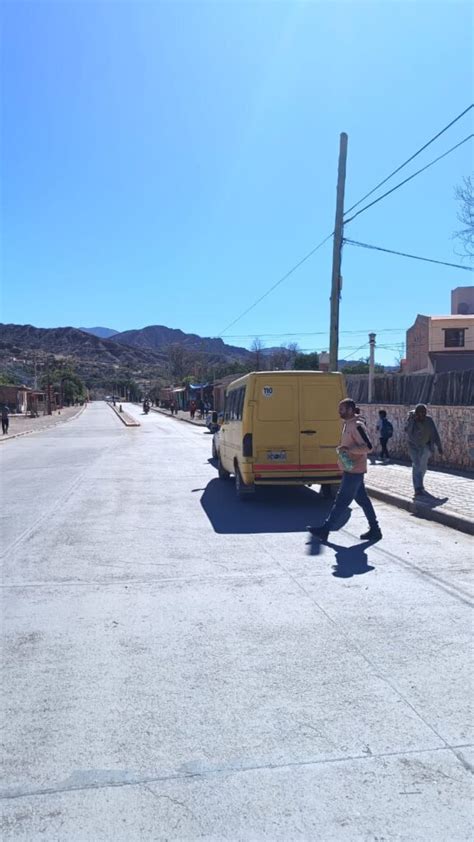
[{"x1": 214, "y1": 371, "x2": 346, "y2": 499}]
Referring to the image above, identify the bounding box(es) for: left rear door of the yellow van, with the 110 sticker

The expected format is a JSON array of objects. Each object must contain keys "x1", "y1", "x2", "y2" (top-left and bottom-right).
[{"x1": 253, "y1": 374, "x2": 300, "y2": 477}]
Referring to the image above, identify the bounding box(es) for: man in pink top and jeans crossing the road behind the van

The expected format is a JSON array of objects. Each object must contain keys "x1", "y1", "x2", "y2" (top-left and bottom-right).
[{"x1": 308, "y1": 398, "x2": 382, "y2": 541}]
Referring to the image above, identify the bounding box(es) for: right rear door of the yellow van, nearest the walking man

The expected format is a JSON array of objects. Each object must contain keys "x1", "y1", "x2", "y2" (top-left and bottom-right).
[{"x1": 298, "y1": 374, "x2": 344, "y2": 476}]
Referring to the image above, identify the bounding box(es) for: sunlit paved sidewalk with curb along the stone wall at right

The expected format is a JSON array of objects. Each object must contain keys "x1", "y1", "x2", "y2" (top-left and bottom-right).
[{"x1": 366, "y1": 463, "x2": 474, "y2": 535}]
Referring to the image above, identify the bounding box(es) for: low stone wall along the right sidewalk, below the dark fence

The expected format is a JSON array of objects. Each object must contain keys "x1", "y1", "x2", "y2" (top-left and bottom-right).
[{"x1": 359, "y1": 404, "x2": 474, "y2": 471}]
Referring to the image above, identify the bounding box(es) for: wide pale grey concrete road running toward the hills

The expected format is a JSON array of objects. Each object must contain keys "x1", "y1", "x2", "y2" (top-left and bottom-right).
[{"x1": 0, "y1": 404, "x2": 474, "y2": 842}]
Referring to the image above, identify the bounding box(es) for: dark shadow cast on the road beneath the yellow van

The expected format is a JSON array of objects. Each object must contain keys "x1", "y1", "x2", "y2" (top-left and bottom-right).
[{"x1": 200, "y1": 476, "x2": 348, "y2": 534}]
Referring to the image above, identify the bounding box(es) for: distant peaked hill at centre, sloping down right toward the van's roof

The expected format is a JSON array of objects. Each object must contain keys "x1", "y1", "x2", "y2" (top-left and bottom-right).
[{"x1": 113, "y1": 325, "x2": 251, "y2": 360}]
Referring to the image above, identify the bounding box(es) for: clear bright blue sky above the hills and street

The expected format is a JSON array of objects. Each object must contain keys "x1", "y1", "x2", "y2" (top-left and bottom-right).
[{"x1": 2, "y1": 0, "x2": 473, "y2": 363}]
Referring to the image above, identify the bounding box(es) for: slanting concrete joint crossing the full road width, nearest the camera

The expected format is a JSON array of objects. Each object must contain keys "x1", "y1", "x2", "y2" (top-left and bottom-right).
[{"x1": 0, "y1": 743, "x2": 474, "y2": 801}]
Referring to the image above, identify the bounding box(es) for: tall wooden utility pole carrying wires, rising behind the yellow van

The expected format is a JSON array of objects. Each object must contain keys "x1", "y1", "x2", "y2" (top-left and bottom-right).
[{"x1": 329, "y1": 132, "x2": 347, "y2": 371}]
